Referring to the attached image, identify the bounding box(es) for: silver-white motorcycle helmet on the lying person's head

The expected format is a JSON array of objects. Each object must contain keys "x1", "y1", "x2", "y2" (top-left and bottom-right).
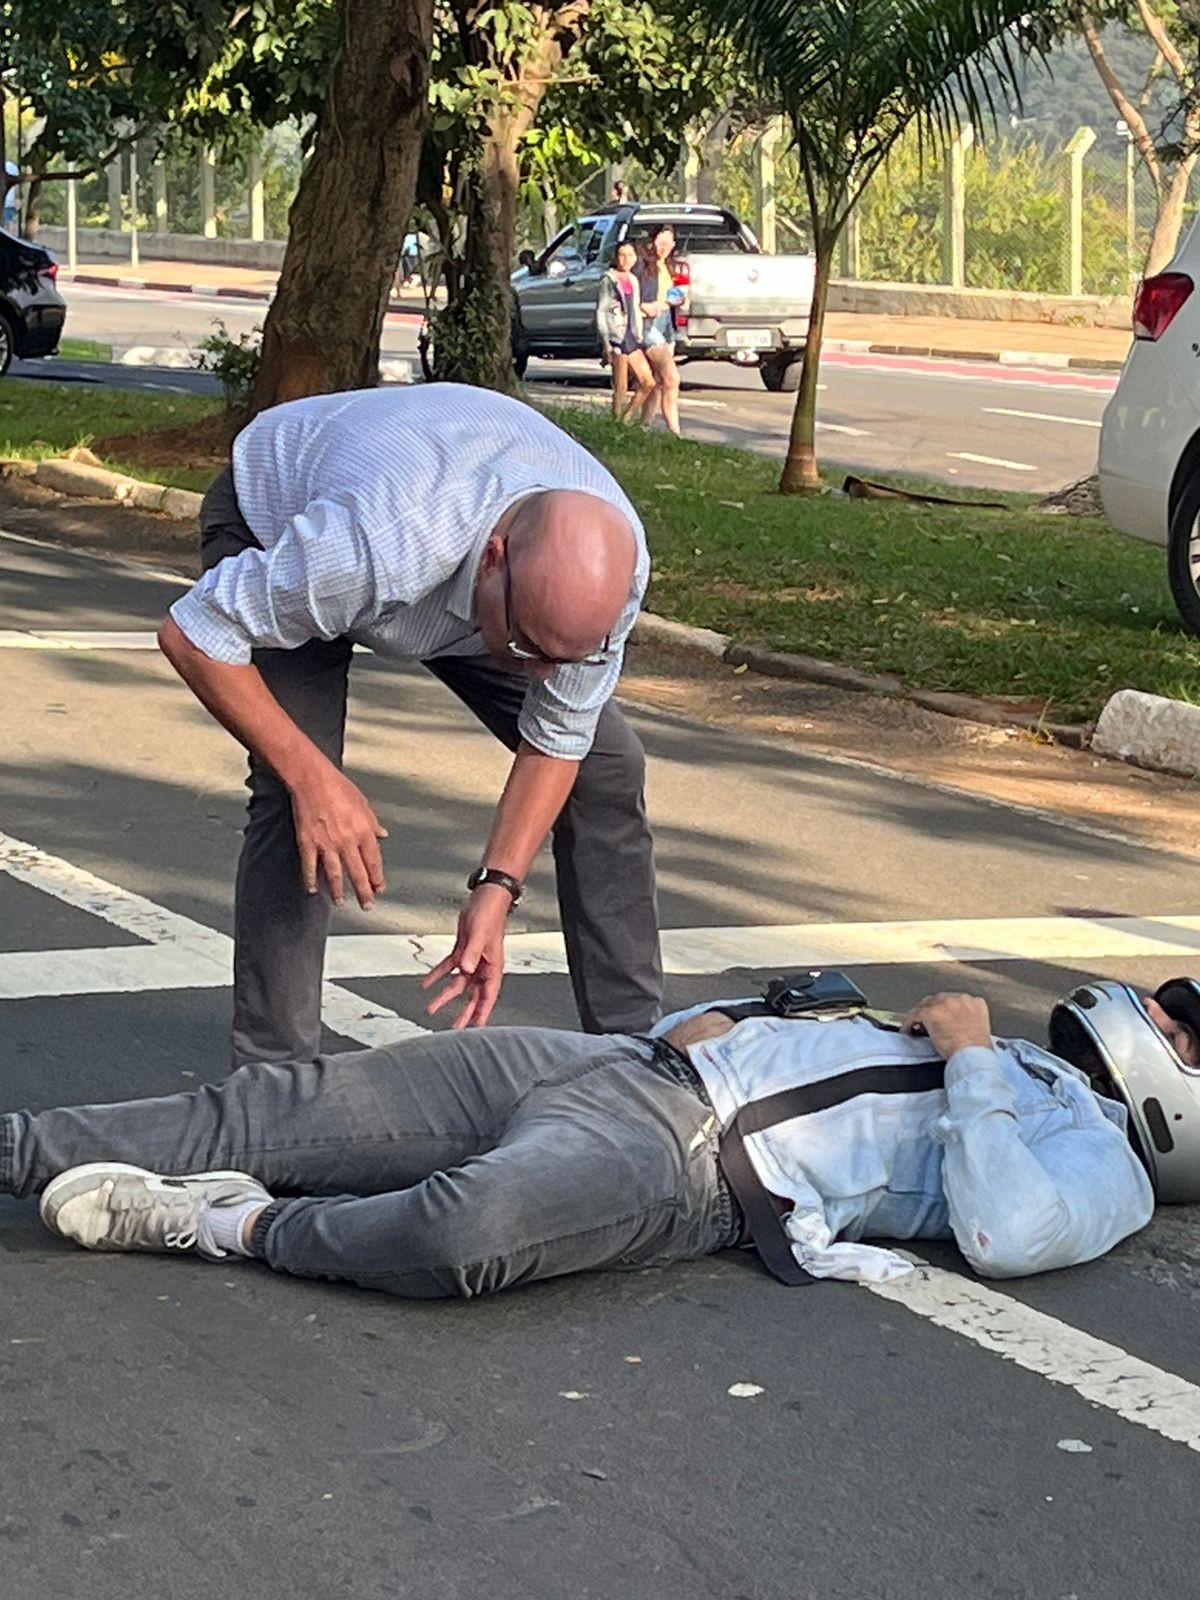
[{"x1": 1050, "y1": 978, "x2": 1200, "y2": 1203}]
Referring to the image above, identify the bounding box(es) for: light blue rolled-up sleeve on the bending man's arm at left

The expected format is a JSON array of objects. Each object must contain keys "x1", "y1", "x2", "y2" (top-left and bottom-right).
[{"x1": 171, "y1": 501, "x2": 381, "y2": 666}]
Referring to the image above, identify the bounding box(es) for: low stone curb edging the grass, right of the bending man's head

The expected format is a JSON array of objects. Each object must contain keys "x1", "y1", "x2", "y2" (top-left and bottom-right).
[{"x1": 634, "y1": 611, "x2": 1094, "y2": 750}]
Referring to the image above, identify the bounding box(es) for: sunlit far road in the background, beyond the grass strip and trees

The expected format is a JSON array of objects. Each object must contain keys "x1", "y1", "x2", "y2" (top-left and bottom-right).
[{"x1": 47, "y1": 283, "x2": 1115, "y2": 491}]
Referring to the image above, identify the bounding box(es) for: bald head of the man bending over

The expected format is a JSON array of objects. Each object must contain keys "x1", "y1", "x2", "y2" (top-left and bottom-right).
[{"x1": 504, "y1": 490, "x2": 637, "y2": 661}]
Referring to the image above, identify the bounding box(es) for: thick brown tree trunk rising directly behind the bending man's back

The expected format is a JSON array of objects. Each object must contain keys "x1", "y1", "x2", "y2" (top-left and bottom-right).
[{"x1": 251, "y1": 0, "x2": 434, "y2": 411}]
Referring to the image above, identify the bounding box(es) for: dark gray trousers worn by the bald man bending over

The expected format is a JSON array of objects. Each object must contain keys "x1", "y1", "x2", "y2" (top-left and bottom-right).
[{"x1": 200, "y1": 470, "x2": 662, "y2": 1067}]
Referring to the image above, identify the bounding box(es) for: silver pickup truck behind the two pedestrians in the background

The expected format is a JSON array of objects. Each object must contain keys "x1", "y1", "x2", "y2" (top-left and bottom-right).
[{"x1": 512, "y1": 205, "x2": 813, "y2": 390}]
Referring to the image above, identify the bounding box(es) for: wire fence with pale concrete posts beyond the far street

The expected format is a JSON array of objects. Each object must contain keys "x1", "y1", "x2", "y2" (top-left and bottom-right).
[{"x1": 32, "y1": 122, "x2": 1192, "y2": 294}]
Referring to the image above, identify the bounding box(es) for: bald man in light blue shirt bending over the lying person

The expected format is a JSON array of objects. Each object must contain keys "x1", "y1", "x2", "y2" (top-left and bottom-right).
[{"x1": 158, "y1": 384, "x2": 662, "y2": 1066}]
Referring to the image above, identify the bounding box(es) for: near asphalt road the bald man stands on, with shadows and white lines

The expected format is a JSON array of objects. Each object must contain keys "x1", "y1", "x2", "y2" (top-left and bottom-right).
[{"x1": 0, "y1": 538, "x2": 1200, "y2": 1600}]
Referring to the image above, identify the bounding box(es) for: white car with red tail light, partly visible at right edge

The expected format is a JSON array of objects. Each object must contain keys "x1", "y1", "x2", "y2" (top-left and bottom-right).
[{"x1": 1099, "y1": 224, "x2": 1200, "y2": 634}]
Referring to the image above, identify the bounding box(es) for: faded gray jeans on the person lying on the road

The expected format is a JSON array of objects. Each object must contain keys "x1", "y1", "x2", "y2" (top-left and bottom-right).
[{"x1": 0, "y1": 1027, "x2": 741, "y2": 1299}]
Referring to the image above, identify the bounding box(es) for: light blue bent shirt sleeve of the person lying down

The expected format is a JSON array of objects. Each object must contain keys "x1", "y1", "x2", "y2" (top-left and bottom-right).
[{"x1": 934, "y1": 1048, "x2": 1154, "y2": 1278}]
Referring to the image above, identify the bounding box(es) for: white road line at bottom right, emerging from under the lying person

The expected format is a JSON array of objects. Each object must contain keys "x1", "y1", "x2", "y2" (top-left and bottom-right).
[{"x1": 864, "y1": 1264, "x2": 1200, "y2": 1450}]
